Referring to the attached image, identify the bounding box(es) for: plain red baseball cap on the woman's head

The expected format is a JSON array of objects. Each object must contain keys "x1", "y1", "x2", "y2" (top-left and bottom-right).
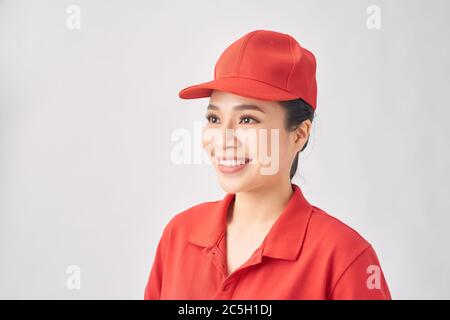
[{"x1": 178, "y1": 30, "x2": 317, "y2": 109}]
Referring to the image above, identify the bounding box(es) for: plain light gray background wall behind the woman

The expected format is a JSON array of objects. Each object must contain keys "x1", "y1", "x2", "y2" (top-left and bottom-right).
[{"x1": 0, "y1": 0, "x2": 450, "y2": 299}]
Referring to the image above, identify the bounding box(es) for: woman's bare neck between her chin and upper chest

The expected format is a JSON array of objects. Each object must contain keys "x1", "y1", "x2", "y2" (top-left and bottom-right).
[{"x1": 228, "y1": 180, "x2": 293, "y2": 228}]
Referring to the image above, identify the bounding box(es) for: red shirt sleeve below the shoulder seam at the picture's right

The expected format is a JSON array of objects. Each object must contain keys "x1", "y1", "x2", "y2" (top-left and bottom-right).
[{"x1": 330, "y1": 246, "x2": 392, "y2": 300}]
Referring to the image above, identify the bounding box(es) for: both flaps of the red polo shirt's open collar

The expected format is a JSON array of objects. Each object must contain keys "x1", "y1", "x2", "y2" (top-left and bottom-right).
[{"x1": 188, "y1": 184, "x2": 312, "y2": 260}]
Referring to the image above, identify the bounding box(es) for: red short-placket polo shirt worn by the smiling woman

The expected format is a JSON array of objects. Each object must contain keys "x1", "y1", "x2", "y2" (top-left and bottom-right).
[{"x1": 144, "y1": 184, "x2": 391, "y2": 300}]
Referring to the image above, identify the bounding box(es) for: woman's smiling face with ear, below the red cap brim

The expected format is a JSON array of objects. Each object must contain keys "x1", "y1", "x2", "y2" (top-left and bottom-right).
[{"x1": 203, "y1": 90, "x2": 309, "y2": 193}]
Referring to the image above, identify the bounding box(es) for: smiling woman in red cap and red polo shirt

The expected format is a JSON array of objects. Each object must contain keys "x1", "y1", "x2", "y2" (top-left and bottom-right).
[{"x1": 144, "y1": 30, "x2": 391, "y2": 299}]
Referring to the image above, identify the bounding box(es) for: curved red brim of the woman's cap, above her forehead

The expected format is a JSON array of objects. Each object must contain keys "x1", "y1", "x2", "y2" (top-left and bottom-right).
[{"x1": 178, "y1": 77, "x2": 299, "y2": 101}]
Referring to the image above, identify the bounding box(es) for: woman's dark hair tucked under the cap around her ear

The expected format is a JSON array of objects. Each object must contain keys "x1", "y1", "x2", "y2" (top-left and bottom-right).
[{"x1": 278, "y1": 99, "x2": 314, "y2": 180}]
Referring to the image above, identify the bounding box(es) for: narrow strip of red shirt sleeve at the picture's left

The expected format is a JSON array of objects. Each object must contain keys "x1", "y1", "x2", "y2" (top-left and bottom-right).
[{"x1": 144, "y1": 221, "x2": 168, "y2": 300}]
